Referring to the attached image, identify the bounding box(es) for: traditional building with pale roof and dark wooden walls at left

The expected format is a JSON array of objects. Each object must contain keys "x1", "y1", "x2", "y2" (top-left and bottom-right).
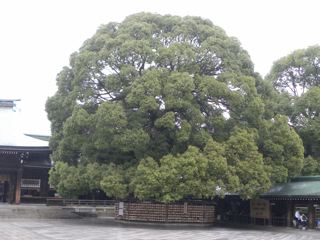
[{"x1": 0, "y1": 99, "x2": 51, "y2": 204}]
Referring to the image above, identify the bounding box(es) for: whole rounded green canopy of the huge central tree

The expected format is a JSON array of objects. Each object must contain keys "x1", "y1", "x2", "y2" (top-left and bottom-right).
[{"x1": 46, "y1": 13, "x2": 303, "y2": 202}]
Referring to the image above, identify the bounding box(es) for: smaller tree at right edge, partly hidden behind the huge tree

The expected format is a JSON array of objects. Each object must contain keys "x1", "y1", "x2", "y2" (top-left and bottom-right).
[{"x1": 267, "y1": 45, "x2": 320, "y2": 175}]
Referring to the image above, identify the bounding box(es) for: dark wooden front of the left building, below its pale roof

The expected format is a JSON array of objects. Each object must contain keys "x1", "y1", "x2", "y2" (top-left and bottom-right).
[{"x1": 0, "y1": 146, "x2": 51, "y2": 203}]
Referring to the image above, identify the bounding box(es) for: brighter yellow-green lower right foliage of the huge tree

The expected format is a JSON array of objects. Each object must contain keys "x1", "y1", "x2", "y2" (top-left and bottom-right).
[{"x1": 134, "y1": 129, "x2": 271, "y2": 202}]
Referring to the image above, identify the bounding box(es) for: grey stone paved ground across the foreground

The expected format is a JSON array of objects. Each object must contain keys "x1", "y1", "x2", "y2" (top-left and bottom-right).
[{"x1": 0, "y1": 219, "x2": 320, "y2": 240}]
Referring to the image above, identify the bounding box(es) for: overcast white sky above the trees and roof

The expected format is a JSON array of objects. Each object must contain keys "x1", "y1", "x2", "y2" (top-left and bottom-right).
[{"x1": 0, "y1": 0, "x2": 320, "y2": 134}]
